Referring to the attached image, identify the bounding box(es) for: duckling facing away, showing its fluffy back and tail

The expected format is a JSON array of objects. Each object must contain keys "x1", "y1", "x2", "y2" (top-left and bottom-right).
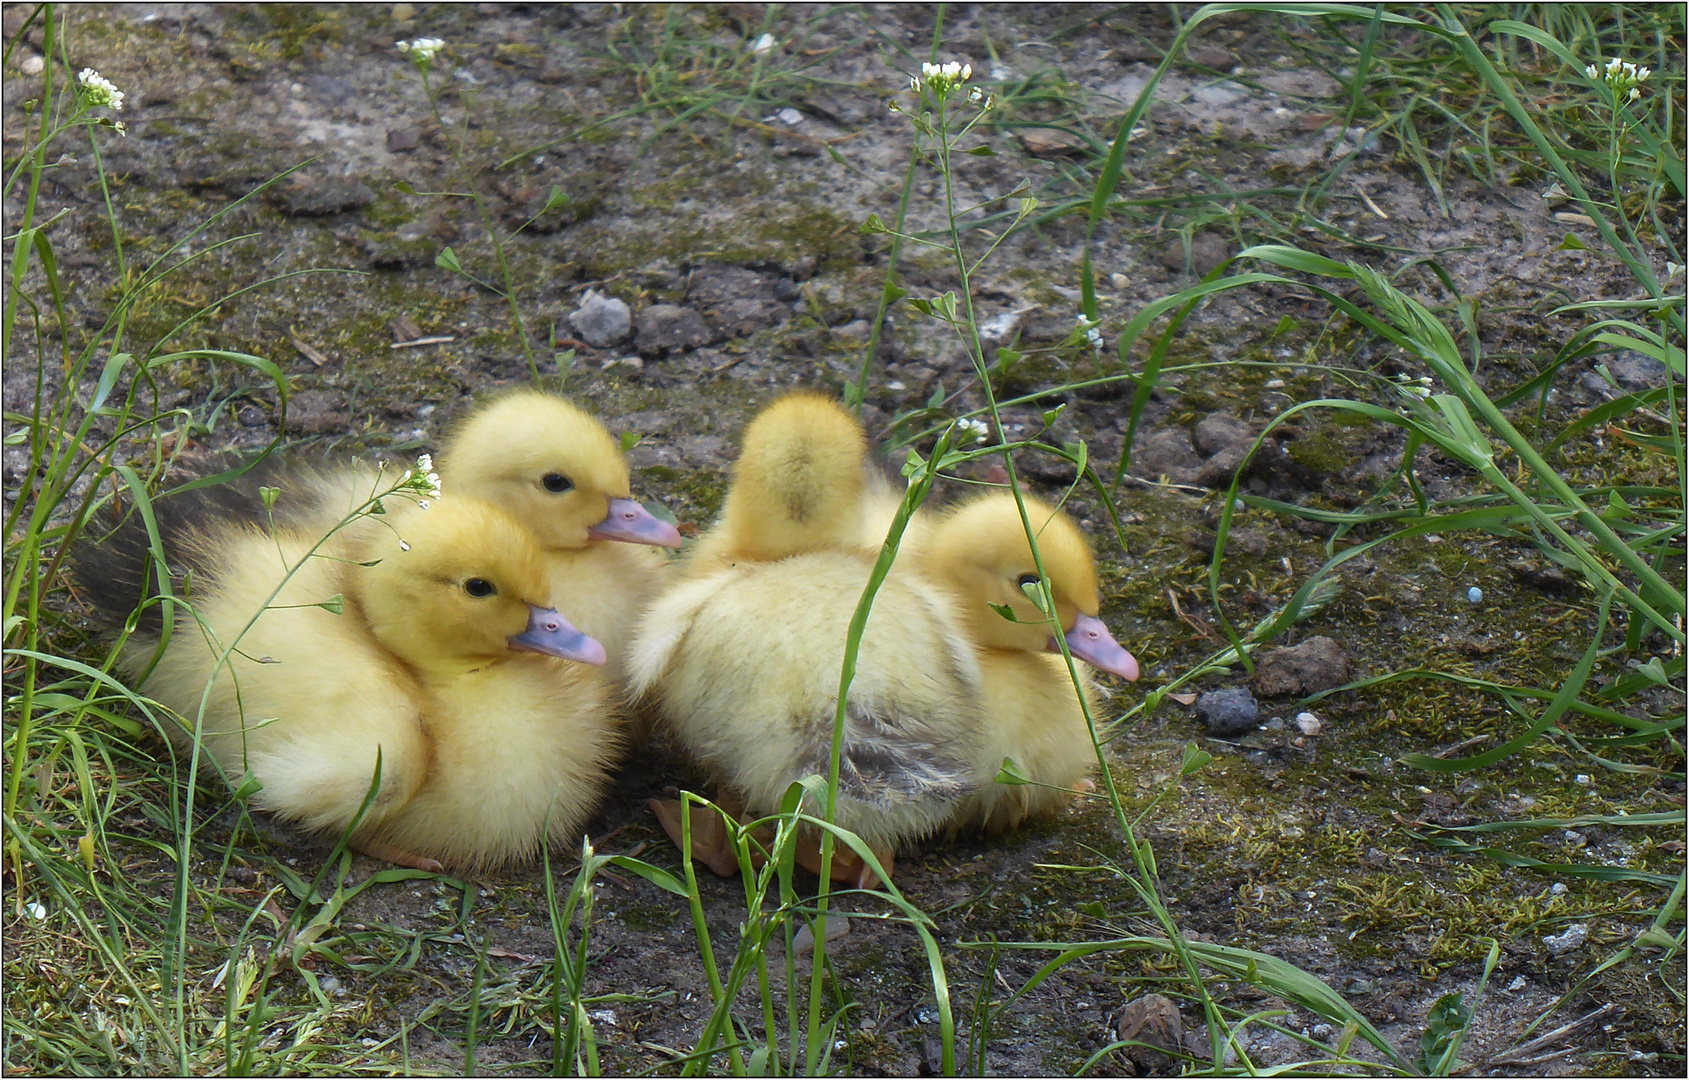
[{"x1": 628, "y1": 394, "x2": 983, "y2": 887}]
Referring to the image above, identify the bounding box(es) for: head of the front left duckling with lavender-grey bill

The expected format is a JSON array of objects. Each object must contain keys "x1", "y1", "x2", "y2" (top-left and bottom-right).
[{"x1": 353, "y1": 495, "x2": 605, "y2": 671}]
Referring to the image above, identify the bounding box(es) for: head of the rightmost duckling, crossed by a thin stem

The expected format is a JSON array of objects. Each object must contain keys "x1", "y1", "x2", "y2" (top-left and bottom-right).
[{"x1": 922, "y1": 492, "x2": 1138, "y2": 679}]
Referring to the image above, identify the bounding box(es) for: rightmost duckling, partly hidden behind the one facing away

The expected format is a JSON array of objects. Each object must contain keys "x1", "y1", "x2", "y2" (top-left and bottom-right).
[{"x1": 910, "y1": 492, "x2": 1138, "y2": 835}]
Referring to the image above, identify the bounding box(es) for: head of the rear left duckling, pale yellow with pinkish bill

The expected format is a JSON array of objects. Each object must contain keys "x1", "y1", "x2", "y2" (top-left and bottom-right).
[{"x1": 439, "y1": 390, "x2": 681, "y2": 549}]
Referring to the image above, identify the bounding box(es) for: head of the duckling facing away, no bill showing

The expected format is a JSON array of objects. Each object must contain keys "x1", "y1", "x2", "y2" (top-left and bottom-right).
[{"x1": 716, "y1": 392, "x2": 868, "y2": 561}]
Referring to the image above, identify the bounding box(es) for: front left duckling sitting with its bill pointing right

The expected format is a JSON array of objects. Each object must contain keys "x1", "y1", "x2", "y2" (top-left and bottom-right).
[{"x1": 78, "y1": 488, "x2": 622, "y2": 870}]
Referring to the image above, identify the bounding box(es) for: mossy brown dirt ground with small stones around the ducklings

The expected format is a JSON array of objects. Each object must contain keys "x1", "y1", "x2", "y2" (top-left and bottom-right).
[{"x1": 5, "y1": 3, "x2": 1684, "y2": 1075}]
